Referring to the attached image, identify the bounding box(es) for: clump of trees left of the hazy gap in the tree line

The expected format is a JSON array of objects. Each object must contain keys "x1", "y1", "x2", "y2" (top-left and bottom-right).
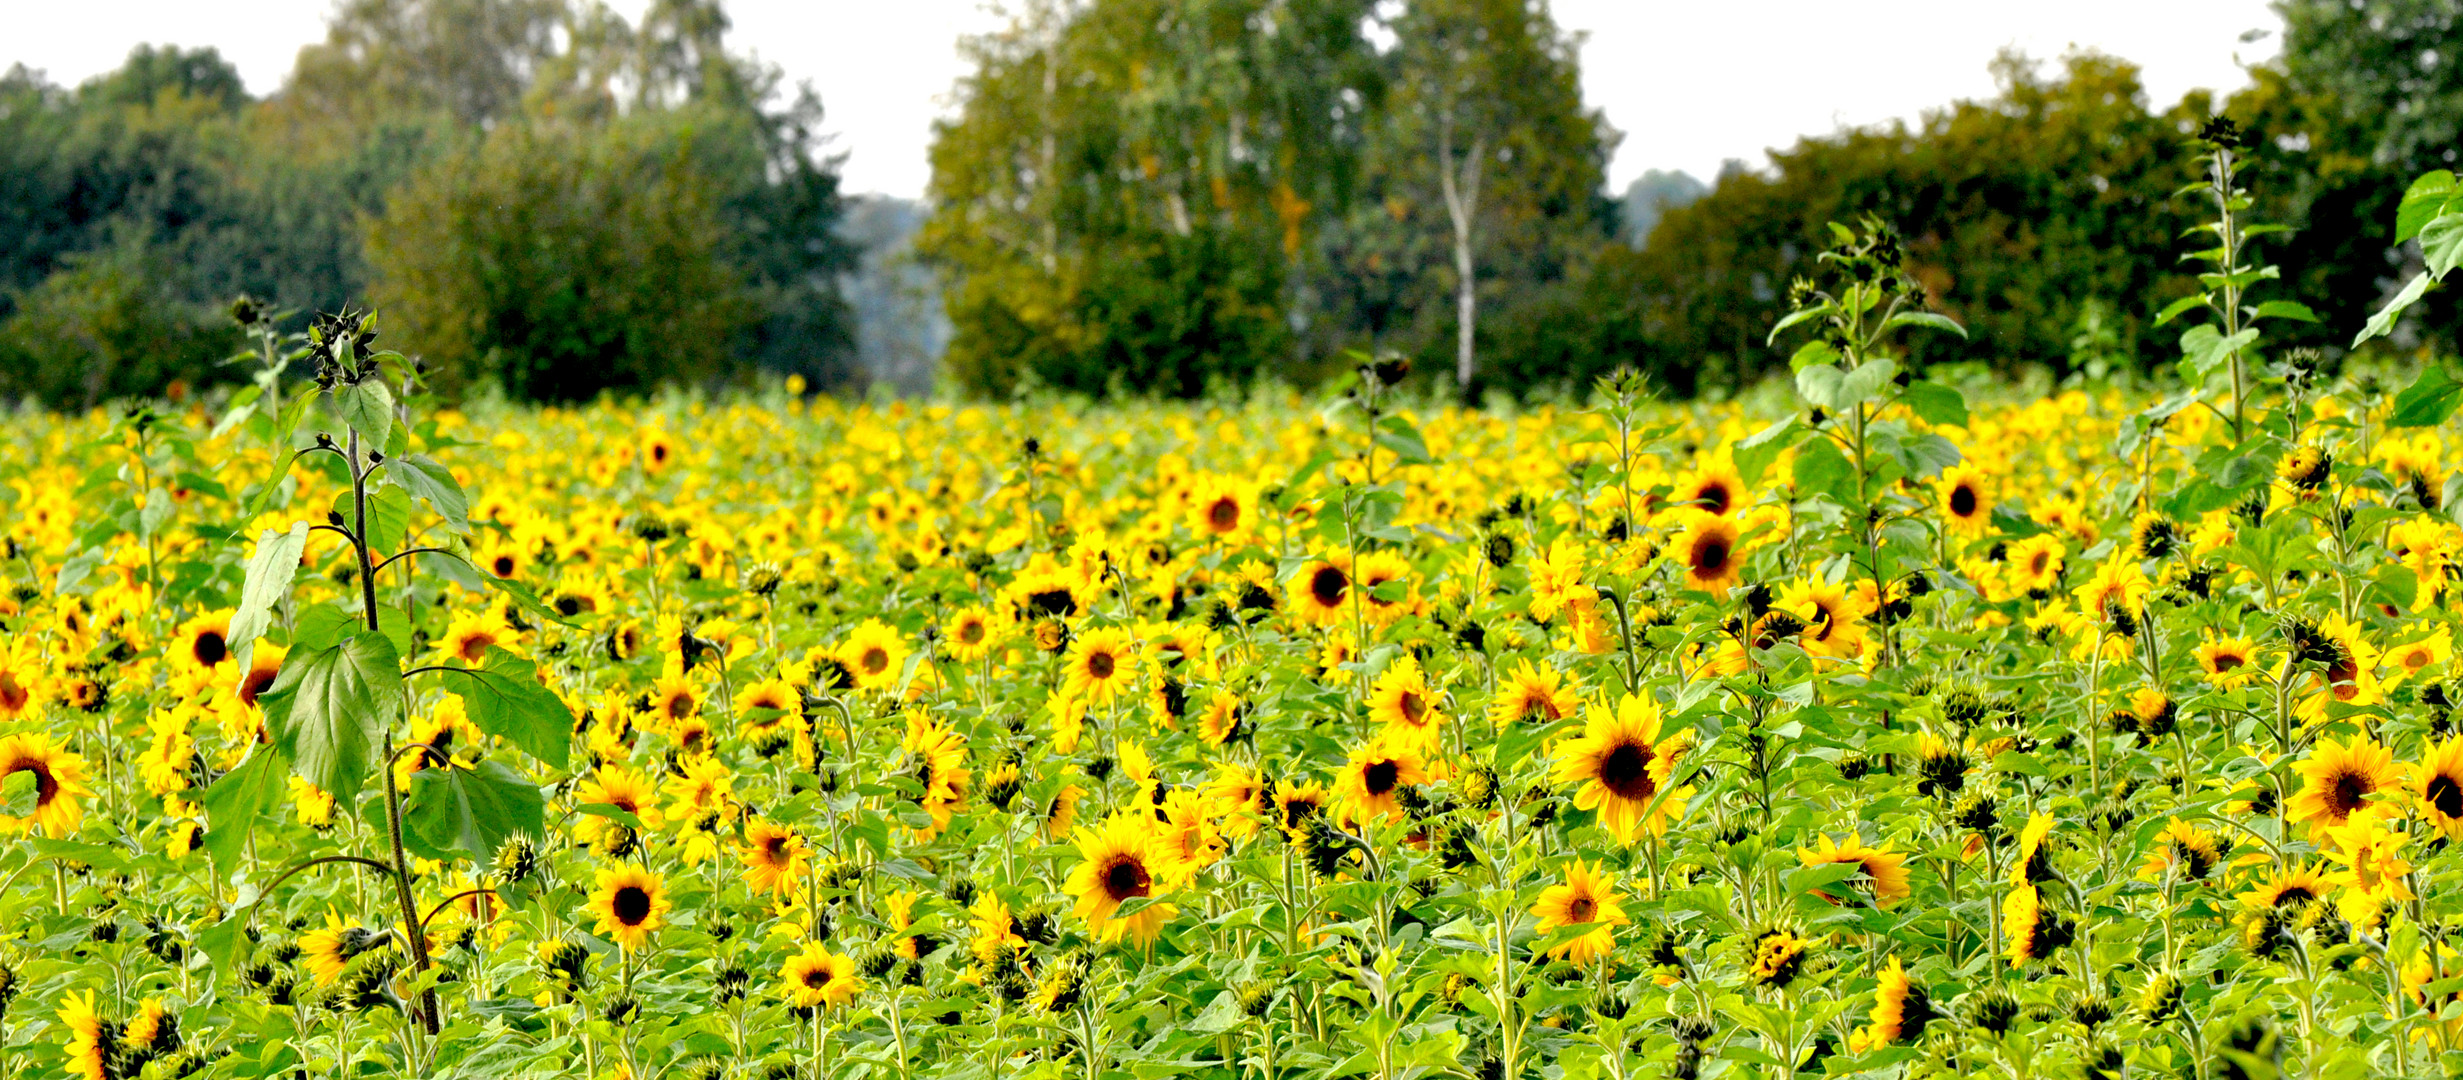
[{"x1": 0, "y1": 0, "x2": 855, "y2": 407}]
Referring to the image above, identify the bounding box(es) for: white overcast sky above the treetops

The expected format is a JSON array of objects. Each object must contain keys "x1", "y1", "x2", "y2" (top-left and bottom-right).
[{"x1": 0, "y1": 0, "x2": 2281, "y2": 197}]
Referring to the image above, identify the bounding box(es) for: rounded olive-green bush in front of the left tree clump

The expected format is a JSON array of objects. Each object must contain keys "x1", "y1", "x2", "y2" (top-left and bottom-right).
[{"x1": 367, "y1": 116, "x2": 756, "y2": 402}]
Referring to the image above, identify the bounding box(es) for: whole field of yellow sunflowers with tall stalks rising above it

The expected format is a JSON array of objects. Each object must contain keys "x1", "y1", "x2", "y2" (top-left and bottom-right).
[{"x1": 0, "y1": 131, "x2": 2463, "y2": 1080}]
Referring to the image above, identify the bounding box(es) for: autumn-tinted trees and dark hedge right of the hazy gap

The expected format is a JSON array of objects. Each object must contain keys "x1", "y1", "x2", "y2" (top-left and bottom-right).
[{"x1": 921, "y1": 0, "x2": 2463, "y2": 395}]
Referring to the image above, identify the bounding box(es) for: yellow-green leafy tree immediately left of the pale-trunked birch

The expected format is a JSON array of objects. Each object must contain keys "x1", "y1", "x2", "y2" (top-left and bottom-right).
[{"x1": 916, "y1": 0, "x2": 1377, "y2": 395}]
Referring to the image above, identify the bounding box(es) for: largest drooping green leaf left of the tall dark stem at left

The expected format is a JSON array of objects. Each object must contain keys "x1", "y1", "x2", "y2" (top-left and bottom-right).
[{"x1": 256, "y1": 631, "x2": 401, "y2": 806}]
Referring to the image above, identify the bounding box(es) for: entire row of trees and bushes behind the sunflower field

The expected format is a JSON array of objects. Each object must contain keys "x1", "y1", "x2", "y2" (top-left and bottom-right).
[{"x1": 0, "y1": 0, "x2": 2463, "y2": 407}]
